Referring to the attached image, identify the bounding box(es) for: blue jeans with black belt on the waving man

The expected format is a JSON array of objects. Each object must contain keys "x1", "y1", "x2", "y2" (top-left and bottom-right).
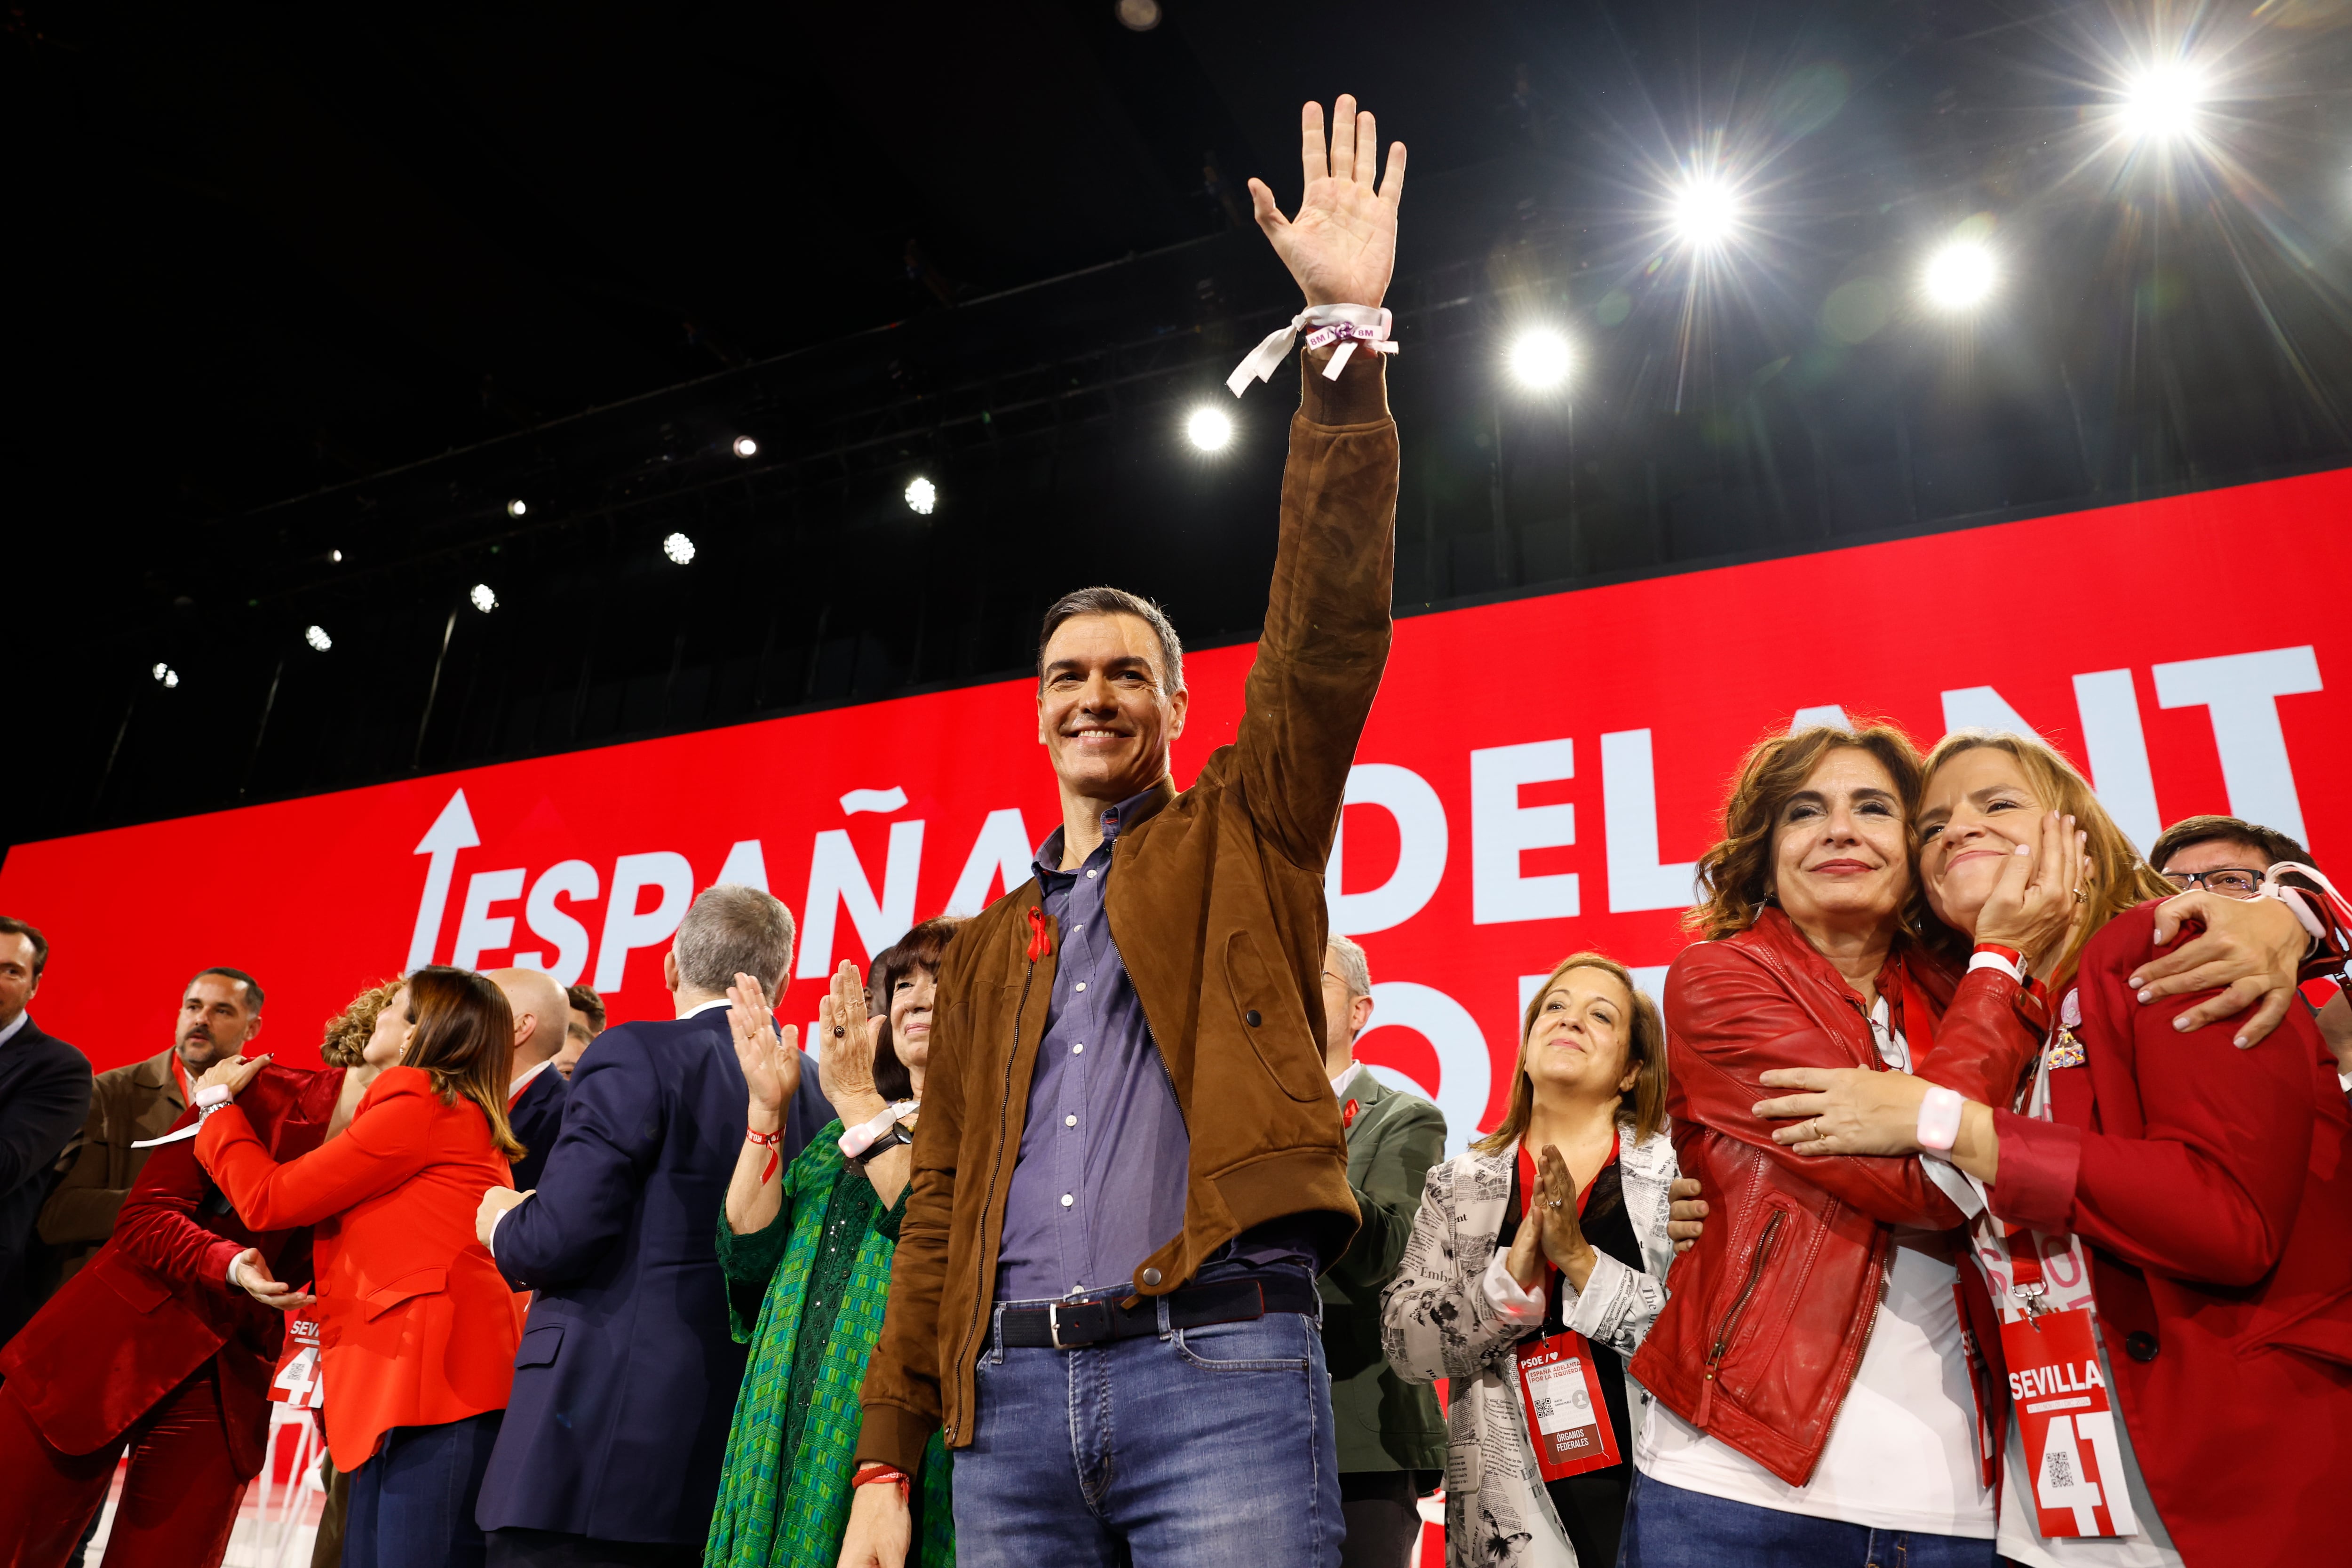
[{"x1": 955, "y1": 1288, "x2": 1345, "y2": 1568}]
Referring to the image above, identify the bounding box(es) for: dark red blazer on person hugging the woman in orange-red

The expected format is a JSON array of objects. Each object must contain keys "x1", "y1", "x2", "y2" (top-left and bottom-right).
[{"x1": 0, "y1": 1063, "x2": 343, "y2": 1476}]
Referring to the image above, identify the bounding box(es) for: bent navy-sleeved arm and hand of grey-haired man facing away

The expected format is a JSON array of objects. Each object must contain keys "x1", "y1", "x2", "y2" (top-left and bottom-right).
[{"x1": 482, "y1": 1023, "x2": 670, "y2": 1290}]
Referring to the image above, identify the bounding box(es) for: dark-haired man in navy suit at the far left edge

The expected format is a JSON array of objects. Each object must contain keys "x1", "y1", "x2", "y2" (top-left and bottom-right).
[{"x1": 0, "y1": 915, "x2": 90, "y2": 1342}]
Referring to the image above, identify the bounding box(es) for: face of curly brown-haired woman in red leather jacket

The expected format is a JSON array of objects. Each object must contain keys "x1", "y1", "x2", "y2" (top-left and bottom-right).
[{"x1": 1769, "y1": 745, "x2": 1910, "y2": 931}]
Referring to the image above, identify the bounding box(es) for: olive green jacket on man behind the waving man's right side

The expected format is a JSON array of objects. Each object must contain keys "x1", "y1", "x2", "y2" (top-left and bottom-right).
[{"x1": 1322, "y1": 1070, "x2": 1446, "y2": 1474}]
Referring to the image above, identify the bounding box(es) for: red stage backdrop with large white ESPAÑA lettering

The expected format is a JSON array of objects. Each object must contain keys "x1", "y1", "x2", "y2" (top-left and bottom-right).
[{"x1": 0, "y1": 470, "x2": 2352, "y2": 1150}]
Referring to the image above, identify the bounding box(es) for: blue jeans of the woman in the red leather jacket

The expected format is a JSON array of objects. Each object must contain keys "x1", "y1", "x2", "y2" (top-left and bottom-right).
[{"x1": 1618, "y1": 1469, "x2": 1999, "y2": 1568}]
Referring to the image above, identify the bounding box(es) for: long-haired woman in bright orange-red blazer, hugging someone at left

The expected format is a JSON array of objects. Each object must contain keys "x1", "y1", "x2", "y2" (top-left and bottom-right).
[{"x1": 195, "y1": 966, "x2": 522, "y2": 1568}]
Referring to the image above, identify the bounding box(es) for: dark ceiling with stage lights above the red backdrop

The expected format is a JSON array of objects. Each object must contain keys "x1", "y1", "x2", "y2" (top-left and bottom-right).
[{"x1": 0, "y1": 0, "x2": 2352, "y2": 860}]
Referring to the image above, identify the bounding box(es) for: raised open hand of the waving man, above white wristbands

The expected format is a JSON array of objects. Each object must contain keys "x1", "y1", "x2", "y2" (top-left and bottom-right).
[{"x1": 1249, "y1": 92, "x2": 1404, "y2": 306}]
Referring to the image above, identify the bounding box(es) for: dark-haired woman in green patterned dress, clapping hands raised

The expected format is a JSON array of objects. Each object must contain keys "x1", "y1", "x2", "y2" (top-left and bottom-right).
[{"x1": 703, "y1": 917, "x2": 957, "y2": 1568}]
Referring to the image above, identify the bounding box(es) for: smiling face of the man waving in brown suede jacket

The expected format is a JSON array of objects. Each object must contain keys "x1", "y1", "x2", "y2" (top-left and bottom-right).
[{"x1": 1037, "y1": 616, "x2": 1190, "y2": 802}]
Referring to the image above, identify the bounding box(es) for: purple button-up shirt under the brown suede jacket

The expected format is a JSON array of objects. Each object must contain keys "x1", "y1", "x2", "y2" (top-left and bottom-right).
[{"x1": 997, "y1": 795, "x2": 1319, "y2": 1302}]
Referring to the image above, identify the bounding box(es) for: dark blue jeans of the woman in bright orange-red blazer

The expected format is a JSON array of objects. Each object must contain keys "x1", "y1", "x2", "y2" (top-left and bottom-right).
[{"x1": 343, "y1": 1410, "x2": 506, "y2": 1568}]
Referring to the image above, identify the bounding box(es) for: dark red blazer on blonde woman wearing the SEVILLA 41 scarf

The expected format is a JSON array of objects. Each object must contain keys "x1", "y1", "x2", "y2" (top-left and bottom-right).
[{"x1": 1992, "y1": 905, "x2": 2352, "y2": 1568}]
